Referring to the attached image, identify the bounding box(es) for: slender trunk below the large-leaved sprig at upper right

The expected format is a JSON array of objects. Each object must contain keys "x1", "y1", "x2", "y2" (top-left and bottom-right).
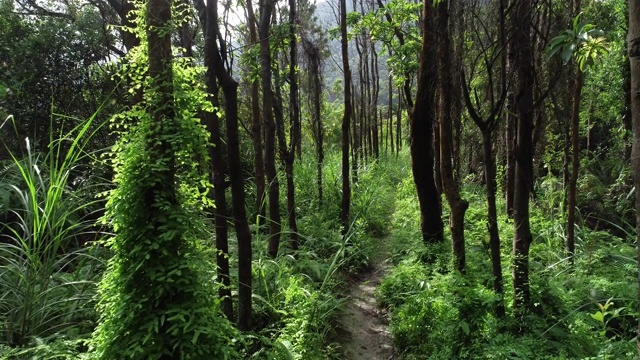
[{"x1": 566, "y1": 69, "x2": 584, "y2": 264}]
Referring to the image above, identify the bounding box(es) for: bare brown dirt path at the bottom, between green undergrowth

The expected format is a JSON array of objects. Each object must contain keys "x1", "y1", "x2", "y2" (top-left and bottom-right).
[{"x1": 342, "y1": 261, "x2": 395, "y2": 360}]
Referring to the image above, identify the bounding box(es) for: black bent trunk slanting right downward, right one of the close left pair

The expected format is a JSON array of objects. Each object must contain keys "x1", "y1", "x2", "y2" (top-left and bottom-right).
[{"x1": 207, "y1": 0, "x2": 252, "y2": 331}]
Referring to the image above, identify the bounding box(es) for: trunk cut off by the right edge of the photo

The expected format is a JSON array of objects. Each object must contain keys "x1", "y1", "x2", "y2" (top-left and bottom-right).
[{"x1": 627, "y1": 0, "x2": 640, "y2": 355}]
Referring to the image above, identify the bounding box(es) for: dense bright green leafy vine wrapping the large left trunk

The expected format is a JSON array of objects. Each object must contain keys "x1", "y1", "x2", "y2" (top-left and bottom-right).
[{"x1": 93, "y1": 4, "x2": 240, "y2": 359}]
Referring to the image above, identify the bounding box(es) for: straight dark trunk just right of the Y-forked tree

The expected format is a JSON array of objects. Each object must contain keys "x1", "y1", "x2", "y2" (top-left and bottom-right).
[{"x1": 511, "y1": 0, "x2": 535, "y2": 315}]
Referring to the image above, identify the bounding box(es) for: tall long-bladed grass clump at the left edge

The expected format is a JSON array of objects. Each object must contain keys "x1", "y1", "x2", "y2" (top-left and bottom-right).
[{"x1": 0, "y1": 115, "x2": 107, "y2": 347}]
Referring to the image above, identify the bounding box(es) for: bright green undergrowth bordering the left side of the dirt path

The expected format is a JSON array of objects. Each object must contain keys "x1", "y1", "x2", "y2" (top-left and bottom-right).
[{"x1": 245, "y1": 152, "x2": 407, "y2": 359}]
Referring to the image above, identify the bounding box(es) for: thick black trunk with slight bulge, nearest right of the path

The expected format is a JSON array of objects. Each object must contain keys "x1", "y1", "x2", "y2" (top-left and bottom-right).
[{"x1": 410, "y1": 0, "x2": 444, "y2": 244}]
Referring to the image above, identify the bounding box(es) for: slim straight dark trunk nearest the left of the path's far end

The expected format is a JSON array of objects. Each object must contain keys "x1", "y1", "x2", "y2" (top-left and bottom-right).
[{"x1": 340, "y1": 0, "x2": 355, "y2": 235}]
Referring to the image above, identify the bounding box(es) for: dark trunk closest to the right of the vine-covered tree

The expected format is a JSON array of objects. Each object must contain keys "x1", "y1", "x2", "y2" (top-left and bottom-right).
[{"x1": 203, "y1": 3, "x2": 233, "y2": 321}]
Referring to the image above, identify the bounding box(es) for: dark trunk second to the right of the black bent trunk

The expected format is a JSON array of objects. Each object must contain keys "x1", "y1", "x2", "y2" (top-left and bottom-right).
[{"x1": 258, "y1": 0, "x2": 282, "y2": 258}]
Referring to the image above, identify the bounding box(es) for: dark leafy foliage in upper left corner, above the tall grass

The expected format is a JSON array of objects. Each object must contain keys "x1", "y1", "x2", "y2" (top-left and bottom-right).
[{"x1": 0, "y1": 0, "x2": 114, "y2": 155}]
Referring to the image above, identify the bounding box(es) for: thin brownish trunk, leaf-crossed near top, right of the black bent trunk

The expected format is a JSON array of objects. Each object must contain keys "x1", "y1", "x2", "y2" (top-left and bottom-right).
[{"x1": 247, "y1": 0, "x2": 266, "y2": 226}]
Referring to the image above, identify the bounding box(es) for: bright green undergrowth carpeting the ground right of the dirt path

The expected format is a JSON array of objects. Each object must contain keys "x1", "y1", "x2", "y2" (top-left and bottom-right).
[{"x1": 377, "y1": 150, "x2": 637, "y2": 359}]
